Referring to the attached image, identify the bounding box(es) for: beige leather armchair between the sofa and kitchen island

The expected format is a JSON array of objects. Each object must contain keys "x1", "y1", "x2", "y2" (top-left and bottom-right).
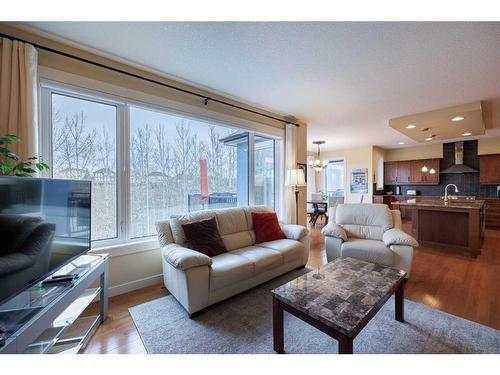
[{"x1": 321, "y1": 204, "x2": 418, "y2": 277}]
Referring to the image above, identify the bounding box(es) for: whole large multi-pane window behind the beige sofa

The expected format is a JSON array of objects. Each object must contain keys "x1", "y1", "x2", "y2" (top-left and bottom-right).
[{"x1": 42, "y1": 86, "x2": 279, "y2": 245}]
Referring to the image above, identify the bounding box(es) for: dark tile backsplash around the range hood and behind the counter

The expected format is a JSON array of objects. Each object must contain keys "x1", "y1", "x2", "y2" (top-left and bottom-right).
[{"x1": 385, "y1": 141, "x2": 497, "y2": 198}]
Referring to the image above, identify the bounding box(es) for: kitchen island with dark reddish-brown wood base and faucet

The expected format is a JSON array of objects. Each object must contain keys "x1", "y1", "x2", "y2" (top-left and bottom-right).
[{"x1": 392, "y1": 197, "x2": 484, "y2": 258}]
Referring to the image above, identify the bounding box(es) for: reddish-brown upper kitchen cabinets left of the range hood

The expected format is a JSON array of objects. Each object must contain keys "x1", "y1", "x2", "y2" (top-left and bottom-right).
[{"x1": 384, "y1": 159, "x2": 439, "y2": 185}]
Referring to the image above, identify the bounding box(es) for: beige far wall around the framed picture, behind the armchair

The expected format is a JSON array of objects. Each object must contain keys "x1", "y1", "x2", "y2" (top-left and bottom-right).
[{"x1": 311, "y1": 146, "x2": 373, "y2": 203}]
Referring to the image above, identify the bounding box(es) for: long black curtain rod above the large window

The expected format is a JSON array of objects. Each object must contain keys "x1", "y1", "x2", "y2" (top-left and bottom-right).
[{"x1": 0, "y1": 33, "x2": 300, "y2": 127}]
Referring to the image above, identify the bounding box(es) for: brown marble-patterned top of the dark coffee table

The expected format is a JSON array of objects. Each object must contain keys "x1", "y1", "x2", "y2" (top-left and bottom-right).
[{"x1": 272, "y1": 258, "x2": 406, "y2": 337}]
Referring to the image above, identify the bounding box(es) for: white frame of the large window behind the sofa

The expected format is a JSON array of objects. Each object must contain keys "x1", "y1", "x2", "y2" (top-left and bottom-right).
[{"x1": 39, "y1": 79, "x2": 284, "y2": 251}]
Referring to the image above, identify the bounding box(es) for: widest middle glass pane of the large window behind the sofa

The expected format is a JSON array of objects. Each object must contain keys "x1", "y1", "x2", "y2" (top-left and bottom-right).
[{"x1": 130, "y1": 106, "x2": 248, "y2": 237}]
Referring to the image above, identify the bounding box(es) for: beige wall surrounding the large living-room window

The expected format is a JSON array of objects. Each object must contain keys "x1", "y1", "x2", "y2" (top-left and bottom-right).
[{"x1": 0, "y1": 23, "x2": 307, "y2": 295}]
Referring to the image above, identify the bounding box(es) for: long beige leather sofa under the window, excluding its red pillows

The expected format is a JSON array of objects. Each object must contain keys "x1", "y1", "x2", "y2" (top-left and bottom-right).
[{"x1": 156, "y1": 207, "x2": 309, "y2": 317}]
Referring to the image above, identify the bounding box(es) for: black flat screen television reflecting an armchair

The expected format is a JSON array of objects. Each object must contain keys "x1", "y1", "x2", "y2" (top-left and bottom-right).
[{"x1": 0, "y1": 176, "x2": 91, "y2": 303}]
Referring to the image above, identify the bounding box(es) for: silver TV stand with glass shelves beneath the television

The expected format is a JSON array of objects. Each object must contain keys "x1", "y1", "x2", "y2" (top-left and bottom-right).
[{"x1": 0, "y1": 254, "x2": 109, "y2": 354}]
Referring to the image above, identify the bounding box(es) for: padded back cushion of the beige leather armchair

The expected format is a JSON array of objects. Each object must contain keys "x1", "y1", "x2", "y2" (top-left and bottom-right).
[{"x1": 335, "y1": 204, "x2": 394, "y2": 231}]
